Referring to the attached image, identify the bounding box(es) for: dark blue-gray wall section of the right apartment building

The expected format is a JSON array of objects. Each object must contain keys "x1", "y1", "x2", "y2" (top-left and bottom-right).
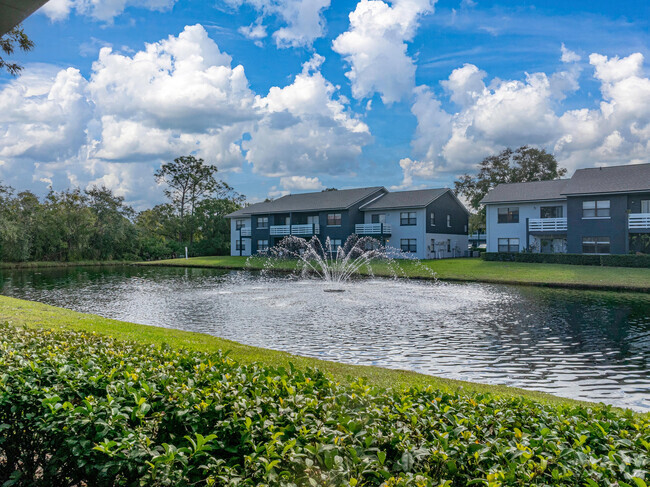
[{"x1": 567, "y1": 194, "x2": 629, "y2": 254}]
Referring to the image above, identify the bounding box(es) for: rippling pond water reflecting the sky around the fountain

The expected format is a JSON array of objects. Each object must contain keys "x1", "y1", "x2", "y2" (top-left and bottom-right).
[{"x1": 0, "y1": 267, "x2": 650, "y2": 410}]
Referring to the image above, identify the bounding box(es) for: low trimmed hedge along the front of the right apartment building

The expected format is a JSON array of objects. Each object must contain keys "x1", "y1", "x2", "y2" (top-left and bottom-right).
[{"x1": 481, "y1": 252, "x2": 650, "y2": 268}]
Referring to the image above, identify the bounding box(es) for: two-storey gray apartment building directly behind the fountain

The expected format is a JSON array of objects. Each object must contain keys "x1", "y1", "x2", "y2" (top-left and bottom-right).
[{"x1": 228, "y1": 186, "x2": 469, "y2": 259}]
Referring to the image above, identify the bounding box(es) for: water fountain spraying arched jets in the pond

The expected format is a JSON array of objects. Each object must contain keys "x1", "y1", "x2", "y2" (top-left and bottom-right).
[{"x1": 258, "y1": 235, "x2": 426, "y2": 292}]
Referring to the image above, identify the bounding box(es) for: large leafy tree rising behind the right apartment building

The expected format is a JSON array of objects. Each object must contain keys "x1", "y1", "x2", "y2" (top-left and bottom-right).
[{"x1": 454, "y1": 145, "x2": 566, "y2": 214}]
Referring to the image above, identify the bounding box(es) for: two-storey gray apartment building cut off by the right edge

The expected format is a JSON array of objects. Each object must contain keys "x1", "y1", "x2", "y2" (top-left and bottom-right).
[{"x1": 482, "y1": 164, "x2": 650, "y2": 254}]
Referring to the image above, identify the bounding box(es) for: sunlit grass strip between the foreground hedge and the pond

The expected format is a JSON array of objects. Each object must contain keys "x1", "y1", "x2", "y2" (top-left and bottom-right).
[{"x1": 0, "y1": 296, "x2": 584, "y2": 405}]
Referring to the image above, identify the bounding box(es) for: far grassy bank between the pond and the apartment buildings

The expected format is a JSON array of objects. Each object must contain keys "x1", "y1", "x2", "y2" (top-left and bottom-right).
[{"x1": 140, "y1": 256, "x2": 650, "y2": 292}]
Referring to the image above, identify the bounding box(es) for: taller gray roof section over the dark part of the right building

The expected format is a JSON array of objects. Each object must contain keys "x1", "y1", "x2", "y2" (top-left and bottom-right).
[{"x1": 562, "y1": 164, "x2": 650, "y2": 195}]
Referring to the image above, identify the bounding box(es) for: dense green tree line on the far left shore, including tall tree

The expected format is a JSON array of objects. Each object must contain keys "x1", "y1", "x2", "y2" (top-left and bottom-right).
[{"x1": 0, "y1": 156, "x2": 244, "y2": 262}]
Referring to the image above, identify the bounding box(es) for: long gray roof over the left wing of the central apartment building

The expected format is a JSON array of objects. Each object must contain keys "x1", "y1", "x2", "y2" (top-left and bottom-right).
[{"x1": 227, "y1": 186, "x2": 386, "y2": 218}]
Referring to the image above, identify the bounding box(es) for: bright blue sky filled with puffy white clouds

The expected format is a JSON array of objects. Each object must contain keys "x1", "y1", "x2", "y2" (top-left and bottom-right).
[{"x1": 0, "y1": 0, "x2": 650, "y2": 209}]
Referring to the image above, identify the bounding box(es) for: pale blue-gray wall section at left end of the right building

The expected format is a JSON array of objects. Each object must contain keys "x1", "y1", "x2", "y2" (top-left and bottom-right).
[{"x1": 485, "y1": 200, "x2": 564, "y2": 252}]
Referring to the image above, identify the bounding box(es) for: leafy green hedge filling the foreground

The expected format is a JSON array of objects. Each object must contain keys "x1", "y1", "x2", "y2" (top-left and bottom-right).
[{"x1": 0, "y1": 325, "x2": 650, "y2": 487}]
